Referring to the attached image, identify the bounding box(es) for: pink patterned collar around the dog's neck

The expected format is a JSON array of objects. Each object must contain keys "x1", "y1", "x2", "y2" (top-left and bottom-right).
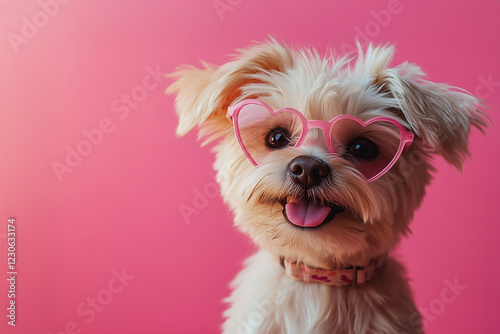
[{"x1": 280, "y1": 253, "x2": 388, "y2": 287}]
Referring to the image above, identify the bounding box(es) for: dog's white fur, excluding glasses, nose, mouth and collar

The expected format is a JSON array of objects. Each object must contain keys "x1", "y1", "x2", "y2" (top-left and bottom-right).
[{"x1": 169, "y1": 40, "x2": 485, "y2": 334}]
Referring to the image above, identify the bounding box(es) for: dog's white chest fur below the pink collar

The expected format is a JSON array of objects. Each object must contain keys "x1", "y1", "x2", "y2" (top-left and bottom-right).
[{"x1": 223, "y1": 251, "x2": 422, "y2": 334}]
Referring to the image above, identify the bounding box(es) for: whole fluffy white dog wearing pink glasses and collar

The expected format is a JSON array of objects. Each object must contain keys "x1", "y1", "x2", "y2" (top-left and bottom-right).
[{"x1": 169, "y1": 40, "x2": 485, "y2": 334}]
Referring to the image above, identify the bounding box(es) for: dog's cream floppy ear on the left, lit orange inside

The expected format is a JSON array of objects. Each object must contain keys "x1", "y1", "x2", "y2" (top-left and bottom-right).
[{"x1": 167, "y1": 40, "x2": 293, "y2": 141}]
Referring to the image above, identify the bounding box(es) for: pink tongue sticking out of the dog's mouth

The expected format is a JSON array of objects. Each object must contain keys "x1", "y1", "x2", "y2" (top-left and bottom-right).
[{"x1": 285, "y1": 197, "x2": 331, "y2": 227}]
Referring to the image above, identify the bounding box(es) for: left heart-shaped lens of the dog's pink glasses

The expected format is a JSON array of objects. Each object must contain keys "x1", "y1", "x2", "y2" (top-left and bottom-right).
[{"x1": 237, "y1": 103, "x2": 302, "y2": 164}]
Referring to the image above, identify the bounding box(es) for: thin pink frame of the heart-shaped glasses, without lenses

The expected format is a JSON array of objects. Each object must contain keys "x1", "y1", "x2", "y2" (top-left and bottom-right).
[{"x1": 226, "y1": 99, "x2": 414, "y2": 182}]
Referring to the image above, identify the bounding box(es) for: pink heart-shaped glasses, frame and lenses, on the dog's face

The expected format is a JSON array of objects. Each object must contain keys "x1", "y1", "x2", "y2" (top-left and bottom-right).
[{"x1": 227, "y1": 99, "x2": 414, "y2": 182}]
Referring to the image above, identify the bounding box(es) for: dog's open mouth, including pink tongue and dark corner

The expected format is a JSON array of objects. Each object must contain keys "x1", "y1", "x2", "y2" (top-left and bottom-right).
[{"x1": 280, "y1": 196, "x2": 345, "y2": 228}]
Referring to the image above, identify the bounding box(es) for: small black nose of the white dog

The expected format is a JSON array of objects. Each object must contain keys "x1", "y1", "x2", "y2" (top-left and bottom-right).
[{"x1": 288, "y1": 155, "x2": 330, "y2": 189}]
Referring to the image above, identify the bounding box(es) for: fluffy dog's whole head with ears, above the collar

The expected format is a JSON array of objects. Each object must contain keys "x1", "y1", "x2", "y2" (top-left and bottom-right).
[{"x1": 170, "y1": 41, "x2": 484, "y2": 266}]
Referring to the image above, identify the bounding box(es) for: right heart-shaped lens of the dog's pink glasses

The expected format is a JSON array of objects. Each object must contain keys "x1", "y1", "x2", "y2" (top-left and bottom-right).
[{"x1": 330, "y1": 118, "x2": 401, "y2": 180}]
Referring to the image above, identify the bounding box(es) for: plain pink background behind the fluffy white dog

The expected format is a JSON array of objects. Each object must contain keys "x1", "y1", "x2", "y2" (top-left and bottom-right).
[{"x1": 0, "y1": 0, "x2": 500, "y2": 334}]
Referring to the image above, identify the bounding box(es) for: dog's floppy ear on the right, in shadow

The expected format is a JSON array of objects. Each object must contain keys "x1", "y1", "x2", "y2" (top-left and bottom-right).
[{"x1": 358, "y1": 46, "x2": 486, "y2": 169}]
